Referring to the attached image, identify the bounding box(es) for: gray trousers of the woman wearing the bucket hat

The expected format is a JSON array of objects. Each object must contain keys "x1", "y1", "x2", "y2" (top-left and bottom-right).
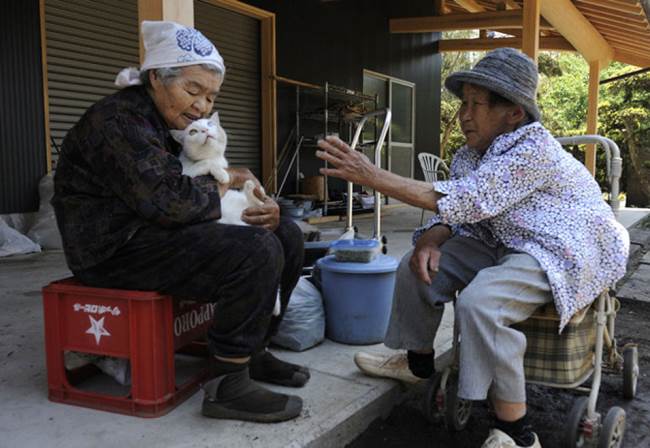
[{"x1": 384, "y1": 236, "x2": 553, "y2": 403}]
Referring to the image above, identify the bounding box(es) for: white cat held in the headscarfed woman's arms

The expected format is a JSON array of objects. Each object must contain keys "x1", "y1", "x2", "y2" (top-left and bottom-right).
[{"x1": 170, "y1": 112, "x2": 264, "y2": 225}]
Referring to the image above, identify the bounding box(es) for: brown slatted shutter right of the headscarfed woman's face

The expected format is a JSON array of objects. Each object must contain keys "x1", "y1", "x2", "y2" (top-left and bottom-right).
[{"x1": 194, "y1": 0, "x2": 262, "y2": 177}]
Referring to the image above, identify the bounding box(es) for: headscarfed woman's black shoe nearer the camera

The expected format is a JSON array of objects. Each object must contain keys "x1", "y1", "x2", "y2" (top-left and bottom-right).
[{"x1": 201, "y1": 369, "x2": 302, "y2": 423}]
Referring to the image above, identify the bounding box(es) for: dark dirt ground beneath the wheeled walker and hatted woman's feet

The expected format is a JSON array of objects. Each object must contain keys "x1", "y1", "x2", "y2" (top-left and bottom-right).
[{"x1": 348, "y1": 300, "x2": 650, "y2": 448}]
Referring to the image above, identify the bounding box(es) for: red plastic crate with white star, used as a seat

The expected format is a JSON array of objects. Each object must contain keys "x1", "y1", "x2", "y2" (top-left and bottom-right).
[{"x1": 43, "y1": 278, "x2": 214, "y2": 417}]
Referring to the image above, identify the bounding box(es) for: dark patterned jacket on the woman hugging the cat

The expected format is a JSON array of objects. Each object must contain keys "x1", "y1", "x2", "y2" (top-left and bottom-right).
[{"x1": 52, "y1": 87, "x2": 221, "y2": 272}]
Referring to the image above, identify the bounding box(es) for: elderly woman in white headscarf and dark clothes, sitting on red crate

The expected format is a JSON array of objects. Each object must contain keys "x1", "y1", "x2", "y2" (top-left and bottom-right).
[{"x1": 52, "y1": 21, "x2": 309, "y2": 422}]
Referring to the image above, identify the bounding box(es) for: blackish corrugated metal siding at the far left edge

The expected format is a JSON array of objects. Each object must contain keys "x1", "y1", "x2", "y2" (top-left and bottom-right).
[{"x1": 0, "y1": 0, "x2": 47, "y2": 213}]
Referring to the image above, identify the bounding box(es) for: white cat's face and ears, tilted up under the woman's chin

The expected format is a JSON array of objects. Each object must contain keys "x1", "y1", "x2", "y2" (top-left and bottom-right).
[{"x1": 170, "y1": 112, "x2": 228, "y2": 161}]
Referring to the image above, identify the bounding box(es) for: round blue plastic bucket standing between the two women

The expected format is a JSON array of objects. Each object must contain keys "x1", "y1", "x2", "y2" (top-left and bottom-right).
[{"x1": 317, "y1": 255, "x2": 398, "y2": 345}]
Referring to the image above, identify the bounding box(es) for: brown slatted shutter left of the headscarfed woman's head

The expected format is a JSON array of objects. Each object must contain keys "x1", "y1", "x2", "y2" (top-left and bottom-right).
[{"x1": 45, "y1": 0, "x2": 140, "y2": 161}]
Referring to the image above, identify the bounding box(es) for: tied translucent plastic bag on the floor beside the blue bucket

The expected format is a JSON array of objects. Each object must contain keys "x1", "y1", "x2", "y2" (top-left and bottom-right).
[{"x1": 271, "y1": 277, "x2": 325, "y2": 352}]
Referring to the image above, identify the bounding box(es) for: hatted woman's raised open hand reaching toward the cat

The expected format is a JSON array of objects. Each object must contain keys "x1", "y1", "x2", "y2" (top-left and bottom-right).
[{"x1": 316, "y1": 136, "x2": 378, "y2": 186}]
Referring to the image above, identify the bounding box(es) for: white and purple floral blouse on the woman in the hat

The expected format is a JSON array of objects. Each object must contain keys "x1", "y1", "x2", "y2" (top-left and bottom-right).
[{"x1": 413, "y1": 122, "x2": 629, "y2": 331}]
